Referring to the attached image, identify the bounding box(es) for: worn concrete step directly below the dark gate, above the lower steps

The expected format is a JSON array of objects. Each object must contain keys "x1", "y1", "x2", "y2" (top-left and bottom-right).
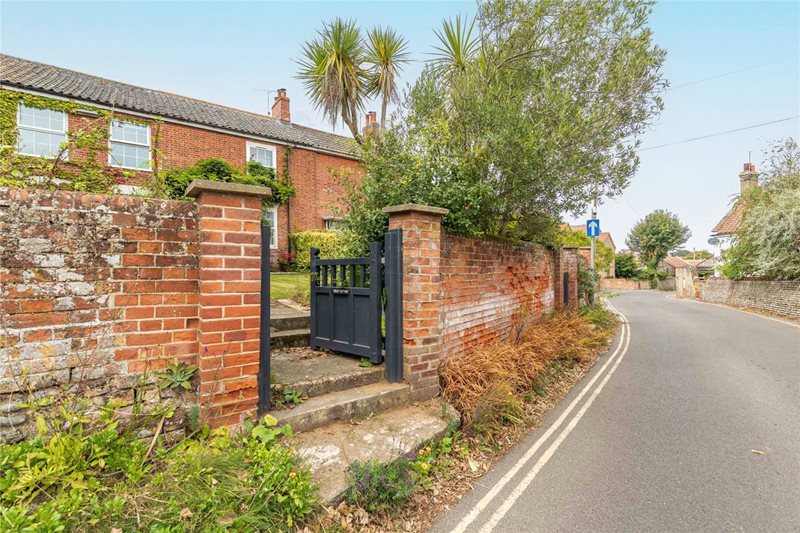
[{"x1": 270, "y1": 348, "x2": 385, "y2": 397}]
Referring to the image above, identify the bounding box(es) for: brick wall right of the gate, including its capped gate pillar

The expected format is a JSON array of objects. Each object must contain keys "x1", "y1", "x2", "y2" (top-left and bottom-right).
[{"x1": 384, "y1": 205, "x2": 579, "y2": 400}]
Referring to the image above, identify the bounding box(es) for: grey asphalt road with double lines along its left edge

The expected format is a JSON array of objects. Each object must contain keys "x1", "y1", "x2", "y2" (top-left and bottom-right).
[{"x1": 433, "y1": 291, "x2": 800, "y2": 532}]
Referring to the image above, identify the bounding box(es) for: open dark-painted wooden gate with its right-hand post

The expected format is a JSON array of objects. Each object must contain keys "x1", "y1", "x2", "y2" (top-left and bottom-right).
[{"x1": 311, "y1": 229, "x2": 403, "y2": 381}]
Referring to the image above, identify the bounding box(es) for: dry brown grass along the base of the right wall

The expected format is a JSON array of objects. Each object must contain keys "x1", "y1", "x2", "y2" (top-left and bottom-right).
[{"x1": 439, "y1": 313, "x2": 612, "y2": 424}]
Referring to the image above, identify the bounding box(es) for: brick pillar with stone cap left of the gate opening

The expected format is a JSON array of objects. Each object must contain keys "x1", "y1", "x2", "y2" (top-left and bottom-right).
[{"x1": 186, "y1": 180, "x2": 271, "y2": 427}]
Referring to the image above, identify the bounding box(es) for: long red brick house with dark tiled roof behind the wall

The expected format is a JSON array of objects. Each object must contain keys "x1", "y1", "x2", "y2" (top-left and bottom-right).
[{"x1": 0, "y1": 55, "x2": 361, "y2": 260}]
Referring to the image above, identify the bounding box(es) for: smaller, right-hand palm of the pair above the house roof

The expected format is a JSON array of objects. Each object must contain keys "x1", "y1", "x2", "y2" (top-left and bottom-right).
[{"x1": 366, "y1": 27, "x2": 409, "y2": 128}]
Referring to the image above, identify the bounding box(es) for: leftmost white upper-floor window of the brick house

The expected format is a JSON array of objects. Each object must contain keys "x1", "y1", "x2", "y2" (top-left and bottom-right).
[{"x1": 17, "y1": 104, "x2": 67, "y2": 157}]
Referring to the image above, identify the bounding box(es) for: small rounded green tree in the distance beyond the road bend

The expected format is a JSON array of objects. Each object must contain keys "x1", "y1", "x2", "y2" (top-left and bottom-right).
[{"x1": 625, "y1": 209, "x2": 692, "y2": 270}]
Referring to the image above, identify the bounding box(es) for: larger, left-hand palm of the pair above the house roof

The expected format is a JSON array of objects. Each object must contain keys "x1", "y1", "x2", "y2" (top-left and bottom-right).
[{"x1": 297, "y1": 18, "x2": 369, "y2": 143}]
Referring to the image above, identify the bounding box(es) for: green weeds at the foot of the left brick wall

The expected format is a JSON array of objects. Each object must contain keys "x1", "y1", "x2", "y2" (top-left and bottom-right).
[{"x1": 0, "y1": 401, "x2": 316, "y2": 531}]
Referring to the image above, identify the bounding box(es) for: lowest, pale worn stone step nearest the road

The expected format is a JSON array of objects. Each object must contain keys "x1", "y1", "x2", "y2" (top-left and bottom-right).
[{"x1": 293, "y1": 400, "x2": 458, "y2": 505}]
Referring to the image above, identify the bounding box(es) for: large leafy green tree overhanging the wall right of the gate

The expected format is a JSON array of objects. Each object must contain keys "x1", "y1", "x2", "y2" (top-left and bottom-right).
[{"x1": 348, "y1": 0, "x2": 665, "y2": 248}]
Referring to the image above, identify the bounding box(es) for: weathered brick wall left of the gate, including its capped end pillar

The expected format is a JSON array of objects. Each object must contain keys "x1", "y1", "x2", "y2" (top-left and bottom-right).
[{"x1": 0, "y1": 183, "x2": 265, "y2": 442}]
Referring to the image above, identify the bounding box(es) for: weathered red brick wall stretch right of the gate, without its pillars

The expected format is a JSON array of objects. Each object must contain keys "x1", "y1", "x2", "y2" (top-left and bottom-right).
[{"x1": 442, "y1": 235, "x2": 558, "y2": 357}]
